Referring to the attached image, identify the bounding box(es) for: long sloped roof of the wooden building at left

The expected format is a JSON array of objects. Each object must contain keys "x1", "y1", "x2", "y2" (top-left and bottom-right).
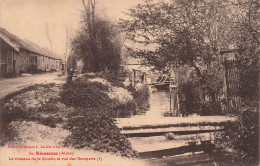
[{"x1": 0, "y1": 27, "x2": 61, "y2": 59}]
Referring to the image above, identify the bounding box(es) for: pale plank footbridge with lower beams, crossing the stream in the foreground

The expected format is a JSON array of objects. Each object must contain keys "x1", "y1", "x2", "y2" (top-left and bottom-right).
[{"x1": 117, "y1": 116, "x2": 236, "y2": 165}]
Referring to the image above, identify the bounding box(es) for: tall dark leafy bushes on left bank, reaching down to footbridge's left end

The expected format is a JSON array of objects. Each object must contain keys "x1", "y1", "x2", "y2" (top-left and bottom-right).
[{"x1": 61, "y1": 79, "x2": 136, "y2": 157}]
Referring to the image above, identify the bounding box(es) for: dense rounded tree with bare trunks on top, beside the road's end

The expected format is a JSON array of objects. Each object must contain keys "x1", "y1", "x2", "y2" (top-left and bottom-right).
[{"x1": 71, "y1": 0, "x2": 122, "y2": 71}]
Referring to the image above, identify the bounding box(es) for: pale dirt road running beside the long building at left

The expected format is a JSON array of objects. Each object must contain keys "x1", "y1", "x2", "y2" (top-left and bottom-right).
[{"x1": 0, "y1": 72, "x2": 65, "y2": 100}]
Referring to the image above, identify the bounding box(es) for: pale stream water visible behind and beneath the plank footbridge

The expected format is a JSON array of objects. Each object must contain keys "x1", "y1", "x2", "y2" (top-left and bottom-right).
[{"x1": 129, "y1": 91, "x2": 215, "y2": 166}]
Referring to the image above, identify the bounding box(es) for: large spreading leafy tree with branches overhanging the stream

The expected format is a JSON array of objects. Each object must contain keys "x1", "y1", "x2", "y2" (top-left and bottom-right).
[{"x1": 121, "y1": 0, "x2": 233, "y2": 99}]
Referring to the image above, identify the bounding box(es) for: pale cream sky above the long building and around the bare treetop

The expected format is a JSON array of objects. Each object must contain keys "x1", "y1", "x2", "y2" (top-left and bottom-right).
[{"x1": 0, "y1": 0, "x2": 140, "y2": 57}]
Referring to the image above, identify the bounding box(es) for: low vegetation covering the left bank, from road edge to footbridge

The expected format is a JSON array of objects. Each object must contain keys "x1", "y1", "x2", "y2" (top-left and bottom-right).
[{"x1": 0, "y1": 80, "x2": 137, "y2": 157}]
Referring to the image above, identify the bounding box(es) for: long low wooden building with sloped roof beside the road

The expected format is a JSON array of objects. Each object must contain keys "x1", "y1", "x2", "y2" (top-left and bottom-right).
[{"x1": 0, "y1": 28, "x2": 62, "y2": 77}]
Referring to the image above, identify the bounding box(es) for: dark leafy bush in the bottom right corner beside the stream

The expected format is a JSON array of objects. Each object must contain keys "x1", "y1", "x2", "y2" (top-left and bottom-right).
[{"x1": 216, "y1": 107, "x2": 259, "y2": 165}]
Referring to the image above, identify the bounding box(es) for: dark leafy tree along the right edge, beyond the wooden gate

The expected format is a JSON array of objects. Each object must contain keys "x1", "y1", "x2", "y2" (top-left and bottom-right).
[{"x1": 234, "y1": 0, "x2": 260, "y2": 106}]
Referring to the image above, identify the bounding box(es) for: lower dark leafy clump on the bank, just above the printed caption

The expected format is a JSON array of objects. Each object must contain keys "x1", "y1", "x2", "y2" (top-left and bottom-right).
[{"x1": 65, "y1": 108, "x2": 136, "y2": 157}]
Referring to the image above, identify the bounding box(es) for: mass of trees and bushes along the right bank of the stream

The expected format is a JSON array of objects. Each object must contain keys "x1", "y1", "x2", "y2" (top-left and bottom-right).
[{"x1": 121, "y1": 0, "x2": 260, "y2": 165}]
